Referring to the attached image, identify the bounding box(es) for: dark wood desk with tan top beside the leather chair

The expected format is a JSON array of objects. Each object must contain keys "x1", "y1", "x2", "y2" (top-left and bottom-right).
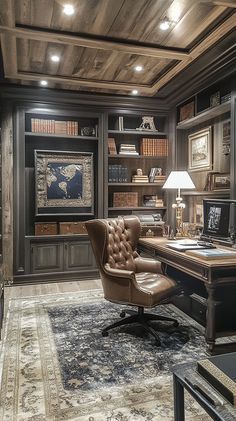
[{"x1": 139, "y1": 237, "x2": 236, "y2": 353}]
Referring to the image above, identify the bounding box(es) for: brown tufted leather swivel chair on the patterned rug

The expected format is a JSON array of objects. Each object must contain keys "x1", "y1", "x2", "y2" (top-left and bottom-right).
[{"x1": 85, "y1": 216, "x2": 180, "y2": 345}]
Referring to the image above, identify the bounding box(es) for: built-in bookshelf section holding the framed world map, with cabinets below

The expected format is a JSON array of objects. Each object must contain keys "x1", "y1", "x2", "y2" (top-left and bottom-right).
[{"x1": 14, "y1": 106, "x2": 104, "y2": 282}]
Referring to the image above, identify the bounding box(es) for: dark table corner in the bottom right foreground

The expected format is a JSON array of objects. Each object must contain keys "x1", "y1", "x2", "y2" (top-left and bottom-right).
[{"x1": 173, "y1": 363, "x2": 236, "y2": 421}]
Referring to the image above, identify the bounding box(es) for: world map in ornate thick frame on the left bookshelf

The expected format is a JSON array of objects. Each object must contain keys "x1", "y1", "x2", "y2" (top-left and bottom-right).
[{"x1": 35, "y1": 150, "x2": 94, "y2": 216}]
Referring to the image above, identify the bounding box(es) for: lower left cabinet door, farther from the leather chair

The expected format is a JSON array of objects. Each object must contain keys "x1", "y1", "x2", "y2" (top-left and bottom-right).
[{"x1": 31, "y1": 243, "x2": 63, "y2": 273}]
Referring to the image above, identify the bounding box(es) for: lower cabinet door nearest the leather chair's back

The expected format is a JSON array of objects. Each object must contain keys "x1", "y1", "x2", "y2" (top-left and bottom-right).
[{"x1": 64, "y1": 240, "x2": 96, "y2": 271}]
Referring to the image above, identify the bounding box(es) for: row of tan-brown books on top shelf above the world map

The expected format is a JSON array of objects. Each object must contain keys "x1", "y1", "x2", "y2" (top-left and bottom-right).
[{"x1": 31, "y1": 118, "x2": 79, "y2": 136}]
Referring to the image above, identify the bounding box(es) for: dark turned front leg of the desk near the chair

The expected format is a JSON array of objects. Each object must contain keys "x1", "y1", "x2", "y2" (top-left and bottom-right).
[{"x1": 205, "y1": 284, "x2": 216, "y2": 352}]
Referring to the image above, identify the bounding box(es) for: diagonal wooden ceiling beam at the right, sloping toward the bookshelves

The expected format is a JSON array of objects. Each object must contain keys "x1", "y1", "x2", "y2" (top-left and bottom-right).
[{"x1": 148, "y1": 13, "x2": 236, "y2": 94}]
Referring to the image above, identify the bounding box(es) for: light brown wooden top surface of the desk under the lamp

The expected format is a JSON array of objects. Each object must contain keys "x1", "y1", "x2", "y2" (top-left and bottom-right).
[{"x1": 139, "y1": 237, "x2": 236, "y2": 268}]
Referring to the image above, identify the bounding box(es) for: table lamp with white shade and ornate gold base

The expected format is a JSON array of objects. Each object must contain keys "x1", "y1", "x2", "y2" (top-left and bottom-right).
[{"x1": 163, "y1": 171, "x2": 195, "y2": 237}]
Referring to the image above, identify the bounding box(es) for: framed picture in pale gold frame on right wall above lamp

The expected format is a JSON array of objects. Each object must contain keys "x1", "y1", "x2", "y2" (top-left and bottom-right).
[{"x1": 188, "y1": 127, "x2": 212, "y2": 171}]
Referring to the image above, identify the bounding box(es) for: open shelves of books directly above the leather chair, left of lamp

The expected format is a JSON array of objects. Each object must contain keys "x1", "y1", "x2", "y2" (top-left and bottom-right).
[{"x1": 107, "y1": 113, "x2": 170, "y2": 216}]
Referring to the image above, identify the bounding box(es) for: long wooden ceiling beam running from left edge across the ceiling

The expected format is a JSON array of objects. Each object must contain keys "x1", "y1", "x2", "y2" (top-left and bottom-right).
[{"x1": 0, "y1": 26, "x2": 189, "y2": 60}]
